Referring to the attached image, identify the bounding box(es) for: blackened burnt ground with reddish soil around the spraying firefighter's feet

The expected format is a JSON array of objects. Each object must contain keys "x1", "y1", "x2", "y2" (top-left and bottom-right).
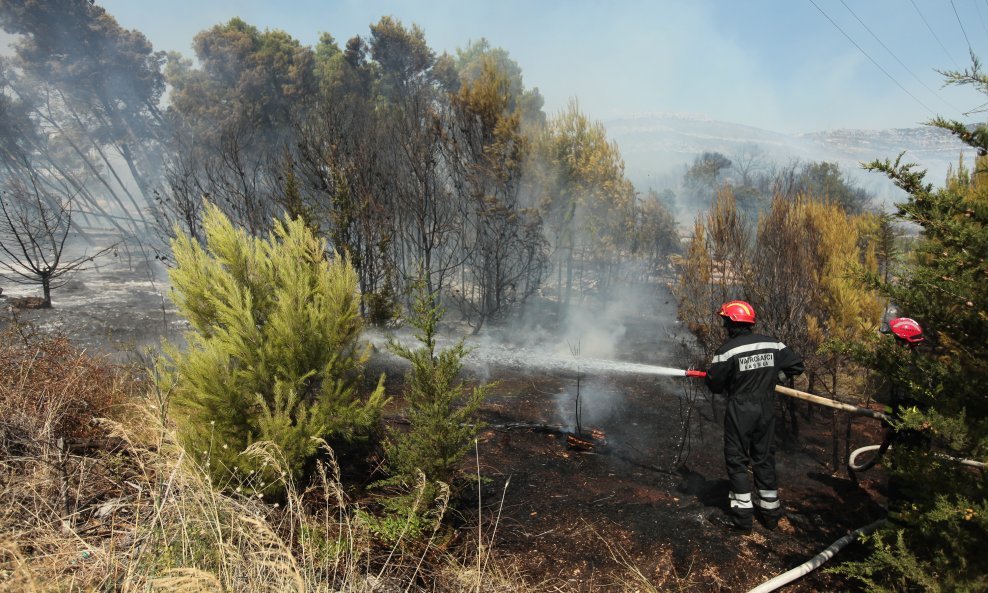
[{"x1": 364, "y1": 306, "x2": 885, "y2": 591}]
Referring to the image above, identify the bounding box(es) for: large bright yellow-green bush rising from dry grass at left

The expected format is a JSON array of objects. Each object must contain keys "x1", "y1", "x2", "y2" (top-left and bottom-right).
[{"x1": 162, "y1": 204, "x2": 386, "y2": 491}]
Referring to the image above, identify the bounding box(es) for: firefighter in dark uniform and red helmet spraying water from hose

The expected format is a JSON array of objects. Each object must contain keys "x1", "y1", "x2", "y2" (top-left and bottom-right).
[{"x1": 706, "y1": 301, "x2": 803, "y2": 532}]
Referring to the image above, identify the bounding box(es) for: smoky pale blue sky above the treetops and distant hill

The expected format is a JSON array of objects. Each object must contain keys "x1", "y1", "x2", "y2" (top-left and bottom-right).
[{"x1": 97, "y1": 0, "x2": 988, "y2": 132}]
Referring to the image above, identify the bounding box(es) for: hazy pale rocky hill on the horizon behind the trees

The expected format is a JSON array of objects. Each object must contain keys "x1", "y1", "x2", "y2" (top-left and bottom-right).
[{"x1": 603, "y1": 114, "x2": 974, "y2": 210}]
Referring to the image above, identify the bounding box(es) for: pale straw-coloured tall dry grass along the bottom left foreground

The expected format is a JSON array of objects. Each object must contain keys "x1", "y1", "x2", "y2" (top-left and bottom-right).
[{"x1": 0, "y1": 418, "x2": 532, "y2": 593}]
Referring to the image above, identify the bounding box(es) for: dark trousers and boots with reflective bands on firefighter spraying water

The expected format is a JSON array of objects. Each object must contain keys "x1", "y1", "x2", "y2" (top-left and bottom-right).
[{"x1": 724, "y1": 397, "x2": 782, "y2": 527}]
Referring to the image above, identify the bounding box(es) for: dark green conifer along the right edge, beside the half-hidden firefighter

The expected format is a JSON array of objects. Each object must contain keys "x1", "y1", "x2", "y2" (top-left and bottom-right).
[{"x1": 840, "y1": 60, "x2": 988, "y2": 591}]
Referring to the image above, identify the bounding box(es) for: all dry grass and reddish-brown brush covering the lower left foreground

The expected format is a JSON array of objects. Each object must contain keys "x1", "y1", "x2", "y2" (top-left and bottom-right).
[{"x1": 0, "y1": 334, "x2": 689, "y2": 593}]
